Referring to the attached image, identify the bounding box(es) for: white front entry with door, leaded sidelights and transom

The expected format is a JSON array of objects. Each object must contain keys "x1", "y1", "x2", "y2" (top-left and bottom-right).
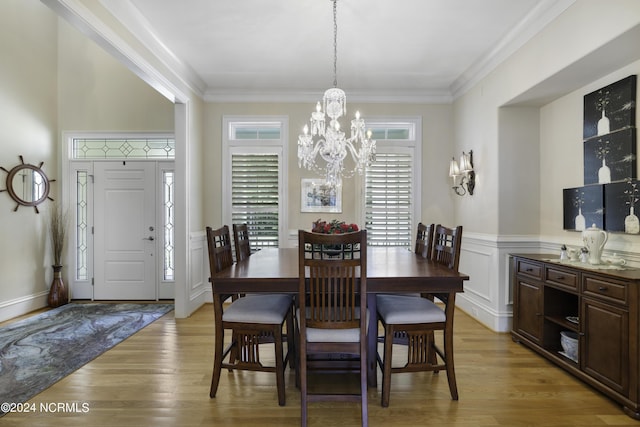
[{"x1": 65, "y1": 135, "x2": 176, "y2": 301}]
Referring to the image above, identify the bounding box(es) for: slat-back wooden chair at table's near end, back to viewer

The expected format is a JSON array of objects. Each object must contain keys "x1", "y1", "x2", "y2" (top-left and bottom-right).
[{"x1": 296, "y1": 230, "x2": 368, "y2": 426}]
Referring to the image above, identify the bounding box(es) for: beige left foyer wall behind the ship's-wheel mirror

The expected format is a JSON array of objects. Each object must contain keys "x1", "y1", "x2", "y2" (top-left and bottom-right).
[{"x1": 0, "y1": 0, "x2": 59, "y2": 308}]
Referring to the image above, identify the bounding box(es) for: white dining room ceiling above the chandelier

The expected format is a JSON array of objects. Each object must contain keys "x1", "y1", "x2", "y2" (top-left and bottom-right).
[{"x1": 101, "y1": 0, "x2": 573, "y2": 102}]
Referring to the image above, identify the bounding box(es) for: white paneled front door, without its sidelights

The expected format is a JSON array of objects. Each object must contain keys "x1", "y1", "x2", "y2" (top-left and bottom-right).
[{"x1": 93, "y1": 161, "x2": 157, "y2": 300}]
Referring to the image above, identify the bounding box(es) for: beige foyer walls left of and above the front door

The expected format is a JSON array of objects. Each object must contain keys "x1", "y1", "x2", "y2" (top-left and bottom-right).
[{"x1": 0, "y1": 0, "x2": 175, "y2": 321}]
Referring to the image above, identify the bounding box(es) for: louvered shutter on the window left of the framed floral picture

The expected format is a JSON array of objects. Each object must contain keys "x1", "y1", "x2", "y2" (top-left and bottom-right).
[{"x1": 231, "y1": 154, "x2": 279, "y2": 251}]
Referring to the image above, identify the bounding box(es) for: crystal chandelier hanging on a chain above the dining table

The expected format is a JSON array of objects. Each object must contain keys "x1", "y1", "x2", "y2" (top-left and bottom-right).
[{"x1": 298, "y1": 0, "x2": 376, "y2": 187}]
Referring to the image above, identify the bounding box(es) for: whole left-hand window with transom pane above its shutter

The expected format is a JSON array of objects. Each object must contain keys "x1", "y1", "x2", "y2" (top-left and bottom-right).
[{"x1": 223, "y1": 117, "x2": 287, "y2": 251}]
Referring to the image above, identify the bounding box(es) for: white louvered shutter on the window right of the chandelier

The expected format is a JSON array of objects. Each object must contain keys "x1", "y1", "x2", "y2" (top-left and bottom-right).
[{"x1": 365, "y1": 152, "x2": 413, "y2": 247}]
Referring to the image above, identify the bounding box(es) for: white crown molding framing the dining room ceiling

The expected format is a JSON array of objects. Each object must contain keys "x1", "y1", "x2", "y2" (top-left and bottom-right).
[{"x1": 41, "y1": 0, "x2": 576, "y2": 104}]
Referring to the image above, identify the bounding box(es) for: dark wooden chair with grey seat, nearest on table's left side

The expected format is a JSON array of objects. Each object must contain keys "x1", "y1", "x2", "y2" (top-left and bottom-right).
[{"x1": 206, "y1": 225, "x2": 294, "y2": 406}]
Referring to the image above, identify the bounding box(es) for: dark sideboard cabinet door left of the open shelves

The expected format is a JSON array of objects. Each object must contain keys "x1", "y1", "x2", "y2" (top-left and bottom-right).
[{"x1": 514, "y1": 277, "x2": 543, "y2": 344}]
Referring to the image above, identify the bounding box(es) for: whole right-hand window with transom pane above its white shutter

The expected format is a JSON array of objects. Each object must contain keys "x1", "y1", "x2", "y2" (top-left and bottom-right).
[{"x1": 364, "y1": 119, "x2": 421, "y2": 248}]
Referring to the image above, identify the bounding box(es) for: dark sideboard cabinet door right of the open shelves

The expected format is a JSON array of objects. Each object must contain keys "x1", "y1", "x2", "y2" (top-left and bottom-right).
[{"x1": 580, "y1": 298, "x2": 629, "y2": 395}]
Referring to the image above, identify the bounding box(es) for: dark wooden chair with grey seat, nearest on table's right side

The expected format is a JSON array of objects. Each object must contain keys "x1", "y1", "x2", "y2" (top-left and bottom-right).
[{"x1": 376, "y1": 224, "x2": 462, "y2": 407}]
